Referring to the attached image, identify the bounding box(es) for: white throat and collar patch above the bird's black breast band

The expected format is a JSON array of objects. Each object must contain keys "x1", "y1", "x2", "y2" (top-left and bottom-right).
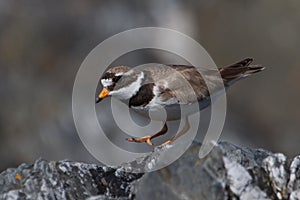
[{"x1": 109, "y1": 72, "x2": 144, "y2": 100}]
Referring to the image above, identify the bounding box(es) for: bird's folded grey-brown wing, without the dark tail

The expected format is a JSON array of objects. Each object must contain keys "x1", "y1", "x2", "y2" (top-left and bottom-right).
[{"x1": 144, "y1": 65, "x2": 223, "y2": 104}]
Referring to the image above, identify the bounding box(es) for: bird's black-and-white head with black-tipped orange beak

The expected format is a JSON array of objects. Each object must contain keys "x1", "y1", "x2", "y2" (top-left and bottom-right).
[{"x1": 96, "y1": 66, "x2": 144, "y2": 103}]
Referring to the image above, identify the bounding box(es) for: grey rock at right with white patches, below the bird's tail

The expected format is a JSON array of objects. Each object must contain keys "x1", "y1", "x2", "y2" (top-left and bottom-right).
[{"x1": 136, "y1": 142, "x2": 300, "y2": 200}]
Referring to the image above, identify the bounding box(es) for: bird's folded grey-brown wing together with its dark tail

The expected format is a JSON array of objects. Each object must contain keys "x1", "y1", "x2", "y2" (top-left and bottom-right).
[{"x1": 139, "y1": 58, "x2": 264, "y2": 104}]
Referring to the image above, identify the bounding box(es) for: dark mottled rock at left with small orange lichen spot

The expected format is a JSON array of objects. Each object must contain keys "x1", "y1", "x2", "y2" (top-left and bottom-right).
[{"x1": 0, "y1": 159, "x2": 142, "y2": 200}]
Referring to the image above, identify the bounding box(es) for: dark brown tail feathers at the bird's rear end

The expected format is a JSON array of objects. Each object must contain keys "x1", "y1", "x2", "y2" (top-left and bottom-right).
[{"x1": 220, "y1": 58, "x2": 265, "y2": 85}]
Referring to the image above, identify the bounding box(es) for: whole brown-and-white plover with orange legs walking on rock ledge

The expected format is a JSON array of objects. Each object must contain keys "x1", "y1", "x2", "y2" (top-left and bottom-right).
[{"x1": 96, "y1": 58, "x2": 265, "y2": 146}]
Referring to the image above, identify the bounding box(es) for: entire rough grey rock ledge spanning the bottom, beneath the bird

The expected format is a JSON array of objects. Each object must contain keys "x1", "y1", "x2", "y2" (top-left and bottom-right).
[{"x1": 0, "y1": 142, "x2": 300, "y2": 200}]
